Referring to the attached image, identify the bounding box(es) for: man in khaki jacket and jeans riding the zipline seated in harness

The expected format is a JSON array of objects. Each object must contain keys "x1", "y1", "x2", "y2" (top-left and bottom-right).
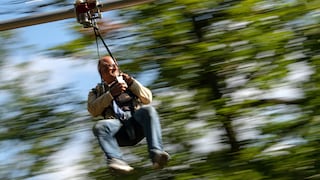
[{"x1": 88, "y1": 56, "x2": 170, "y2": 173}]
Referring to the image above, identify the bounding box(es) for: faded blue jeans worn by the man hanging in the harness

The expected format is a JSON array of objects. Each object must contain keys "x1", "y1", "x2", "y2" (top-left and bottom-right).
[{"x1": 93, "y1": 106, "x2": 163, "y2": 159}]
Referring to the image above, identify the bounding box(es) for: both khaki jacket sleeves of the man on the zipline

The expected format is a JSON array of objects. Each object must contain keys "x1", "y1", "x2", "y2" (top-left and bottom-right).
[{"x1": 87, "y1": 79, "x2": 152, "y2": 119}]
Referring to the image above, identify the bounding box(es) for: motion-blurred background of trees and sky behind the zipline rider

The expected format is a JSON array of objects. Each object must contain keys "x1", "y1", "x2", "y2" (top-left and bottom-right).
[{"x1": 0, "y1": 0, "x2": 320, "y2": 180}]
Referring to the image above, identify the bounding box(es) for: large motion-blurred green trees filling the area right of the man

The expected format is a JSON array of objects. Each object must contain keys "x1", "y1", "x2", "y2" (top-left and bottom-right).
[{"x1": 27, "y1": 0, "x2": 320, "y2": 179}]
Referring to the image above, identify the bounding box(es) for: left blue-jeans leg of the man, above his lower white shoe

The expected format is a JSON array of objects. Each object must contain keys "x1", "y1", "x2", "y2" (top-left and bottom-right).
[{"x1": 93, "y1": 119, "x2": 122, "y2": 159}]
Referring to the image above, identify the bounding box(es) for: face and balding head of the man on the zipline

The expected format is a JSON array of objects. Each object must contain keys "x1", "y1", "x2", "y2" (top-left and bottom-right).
[{"x1": 101, "y1": 57, "x2": 120, "y2": 83}]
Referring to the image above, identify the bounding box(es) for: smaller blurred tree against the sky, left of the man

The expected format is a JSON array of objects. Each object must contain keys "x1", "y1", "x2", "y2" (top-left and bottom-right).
[{"x1": 0, "y1": 61, "x2": 84, "y2": 179}]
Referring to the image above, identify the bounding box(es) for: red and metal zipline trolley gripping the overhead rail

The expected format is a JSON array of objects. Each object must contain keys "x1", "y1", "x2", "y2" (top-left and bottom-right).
[{"x1": 74, "y1": 0, "x2": 101, "y2": 28}]
